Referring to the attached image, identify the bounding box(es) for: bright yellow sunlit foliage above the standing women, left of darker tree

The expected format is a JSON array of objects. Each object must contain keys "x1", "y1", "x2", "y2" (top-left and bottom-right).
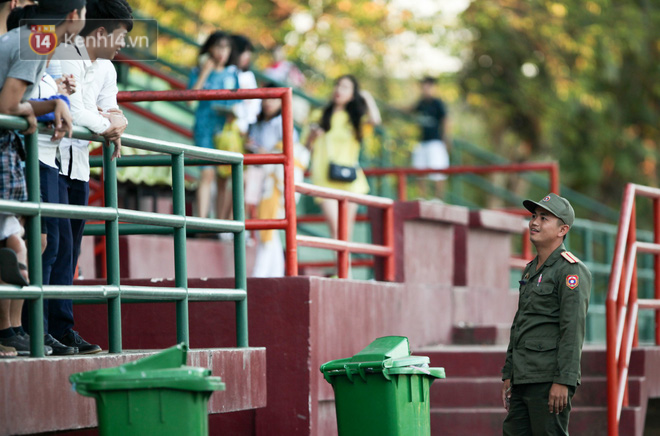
[{"x1": 131, "y1": 0, "x2": 439, "y2": 97}]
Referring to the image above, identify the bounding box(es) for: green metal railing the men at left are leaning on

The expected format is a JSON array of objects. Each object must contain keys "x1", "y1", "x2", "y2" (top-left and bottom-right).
[{"x1": 0, "y1": 115, "x2": 248, "y2": 357}]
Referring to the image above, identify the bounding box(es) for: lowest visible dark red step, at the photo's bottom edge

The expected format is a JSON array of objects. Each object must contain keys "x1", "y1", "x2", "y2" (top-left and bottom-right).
[{"x1": 431, "y1": 407, "x2": 643, "y2": 436}]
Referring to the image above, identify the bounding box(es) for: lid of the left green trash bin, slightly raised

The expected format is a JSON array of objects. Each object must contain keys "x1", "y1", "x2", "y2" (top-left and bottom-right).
[{"x1": 69, "y1": 344, "x2": 225, "y2": 397}]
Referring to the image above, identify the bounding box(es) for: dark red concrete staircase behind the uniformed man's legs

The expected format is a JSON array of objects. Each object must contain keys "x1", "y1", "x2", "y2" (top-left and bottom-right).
[{"x1": 415, "y1": 345, "x2": 660, "y2": 436}]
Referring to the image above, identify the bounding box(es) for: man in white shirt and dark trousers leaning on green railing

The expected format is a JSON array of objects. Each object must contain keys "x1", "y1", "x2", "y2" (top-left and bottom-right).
[{"x1": 48, "y1": 0, "x2": 133, "y2": 354}]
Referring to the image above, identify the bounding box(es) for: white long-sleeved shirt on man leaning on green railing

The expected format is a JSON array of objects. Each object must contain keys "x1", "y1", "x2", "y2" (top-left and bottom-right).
[{"x1": 58, "y1": 41, "x2": 118, "y2": 182}]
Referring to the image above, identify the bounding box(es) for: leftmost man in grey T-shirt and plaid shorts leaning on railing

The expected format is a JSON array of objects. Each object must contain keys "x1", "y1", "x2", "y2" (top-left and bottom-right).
[{"x1": 0, "y1": 0, "x2": 85, "y2": 354}]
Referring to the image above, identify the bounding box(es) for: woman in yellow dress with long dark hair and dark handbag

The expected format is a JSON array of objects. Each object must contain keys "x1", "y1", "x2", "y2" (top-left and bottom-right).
[{"x1": 305, "y1": 75, "x2": 381, "y2": 239}]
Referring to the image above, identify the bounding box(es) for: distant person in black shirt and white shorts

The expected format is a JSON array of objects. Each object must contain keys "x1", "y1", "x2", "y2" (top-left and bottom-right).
[{"x1": 412, "y1": 76, "x2": 451, "y2": 198}]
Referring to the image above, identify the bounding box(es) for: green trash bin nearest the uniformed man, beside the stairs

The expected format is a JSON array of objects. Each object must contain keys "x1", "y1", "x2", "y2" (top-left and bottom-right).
[{"x1": 321, "y1": 336, "x2": 445, "y2": 436}]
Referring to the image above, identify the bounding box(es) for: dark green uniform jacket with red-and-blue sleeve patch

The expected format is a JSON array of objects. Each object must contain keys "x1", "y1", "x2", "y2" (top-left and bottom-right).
[{"x1": 502, "y1": 244, "x2": 591, "y2": 386}]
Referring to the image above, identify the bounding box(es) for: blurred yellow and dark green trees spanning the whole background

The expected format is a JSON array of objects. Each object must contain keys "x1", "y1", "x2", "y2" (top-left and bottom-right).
[{"x1": 126, "y1": 0, "x2": 660, "y2": 208}]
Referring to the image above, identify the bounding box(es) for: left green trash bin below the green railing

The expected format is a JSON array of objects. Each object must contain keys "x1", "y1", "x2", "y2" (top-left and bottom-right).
[{"x1": 69, "y1": 344, "x2": 225, "y2": 436}]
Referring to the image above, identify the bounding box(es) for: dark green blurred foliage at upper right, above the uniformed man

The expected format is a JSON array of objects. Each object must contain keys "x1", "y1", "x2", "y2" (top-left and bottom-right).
[{"x1": 458, "y1": 0, "x2": 660, "y2": 203}]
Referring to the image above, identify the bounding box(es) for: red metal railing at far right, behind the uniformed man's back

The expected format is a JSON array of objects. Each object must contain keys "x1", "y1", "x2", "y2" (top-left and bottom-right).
[{"x1": 605, "y1": 183, "x2": 660, "y2": 436}]
